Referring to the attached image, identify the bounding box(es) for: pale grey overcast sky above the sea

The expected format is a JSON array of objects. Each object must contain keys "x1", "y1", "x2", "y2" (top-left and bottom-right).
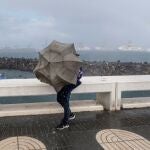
[{"x1": 0, "y1": 0, "x2": 150, "y2": 48}]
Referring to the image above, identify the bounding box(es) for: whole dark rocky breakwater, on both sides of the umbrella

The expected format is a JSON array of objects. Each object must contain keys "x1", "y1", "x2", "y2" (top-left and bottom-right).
[{"x1": 0, "y1": 57, "x2": 150, "y2": 76}]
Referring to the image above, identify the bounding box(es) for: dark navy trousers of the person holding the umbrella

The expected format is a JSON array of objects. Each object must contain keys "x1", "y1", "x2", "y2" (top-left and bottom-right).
[{"x1": 57, "y1": 81, "x2": 81, "y2": 124}]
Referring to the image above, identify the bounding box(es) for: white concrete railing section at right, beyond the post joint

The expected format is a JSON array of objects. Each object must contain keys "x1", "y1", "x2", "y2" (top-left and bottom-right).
[{"x1": 97, "y1": 75, "x2": 150, "y2": 110}]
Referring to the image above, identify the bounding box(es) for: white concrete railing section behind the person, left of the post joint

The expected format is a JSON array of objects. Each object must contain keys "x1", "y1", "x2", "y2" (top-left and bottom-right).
[{"x1": 0, "y1": 77, "x2": 115, "y2": 116}]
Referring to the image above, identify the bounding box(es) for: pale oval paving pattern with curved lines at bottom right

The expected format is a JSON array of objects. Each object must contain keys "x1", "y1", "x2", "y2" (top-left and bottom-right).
[{"x1": 96, "y1": 129, "x2": 150, "y2": 150}]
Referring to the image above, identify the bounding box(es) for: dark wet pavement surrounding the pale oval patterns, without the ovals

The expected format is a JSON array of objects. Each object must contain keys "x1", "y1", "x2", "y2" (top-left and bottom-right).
[{"x1": 0, "y1": 108, "x2": 150, "y2": 150}]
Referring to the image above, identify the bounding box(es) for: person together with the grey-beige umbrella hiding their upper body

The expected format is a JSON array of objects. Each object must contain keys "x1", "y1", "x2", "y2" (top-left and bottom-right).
[{"x1": 33, "y1": 40, "x2": 82, "y2": 130}]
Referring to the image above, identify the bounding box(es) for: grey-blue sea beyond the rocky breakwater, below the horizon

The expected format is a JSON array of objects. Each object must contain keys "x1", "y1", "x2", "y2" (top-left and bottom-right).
[{"x1": 0, "y1": 50, "x2": 150, "y2": 62}]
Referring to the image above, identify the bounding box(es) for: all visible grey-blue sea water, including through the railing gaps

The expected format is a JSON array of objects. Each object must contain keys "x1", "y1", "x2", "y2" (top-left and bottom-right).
[{"x1": 0, "y1": 50, "x2": 150, "y2": 104}]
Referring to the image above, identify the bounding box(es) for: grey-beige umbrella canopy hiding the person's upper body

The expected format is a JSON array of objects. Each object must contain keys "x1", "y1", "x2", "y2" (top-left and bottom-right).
[{"x1": 34, "y1": 41, "x2": 81, "y2": 92}]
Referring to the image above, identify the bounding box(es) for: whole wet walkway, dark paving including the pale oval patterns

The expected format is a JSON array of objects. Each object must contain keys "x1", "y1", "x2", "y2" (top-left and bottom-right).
[{"x1": 0, "y1": 108, "x2": 150, "y2": 150}]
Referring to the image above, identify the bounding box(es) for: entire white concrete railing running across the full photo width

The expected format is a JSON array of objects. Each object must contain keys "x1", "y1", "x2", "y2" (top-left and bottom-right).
[{"x1": 0, "y1": 75, "x2": 150, "y2": 116}]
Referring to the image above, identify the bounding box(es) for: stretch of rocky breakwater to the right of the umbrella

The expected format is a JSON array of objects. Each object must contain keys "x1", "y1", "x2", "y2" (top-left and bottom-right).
[{"x1": 83, "y1": 61, "x2": 150, "y2": 76}]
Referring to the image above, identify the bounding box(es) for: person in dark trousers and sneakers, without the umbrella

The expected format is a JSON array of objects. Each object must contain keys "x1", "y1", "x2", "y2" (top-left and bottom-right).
[{"x1": 56, "y1": 67, "x2": 83, "y2": 130}]
